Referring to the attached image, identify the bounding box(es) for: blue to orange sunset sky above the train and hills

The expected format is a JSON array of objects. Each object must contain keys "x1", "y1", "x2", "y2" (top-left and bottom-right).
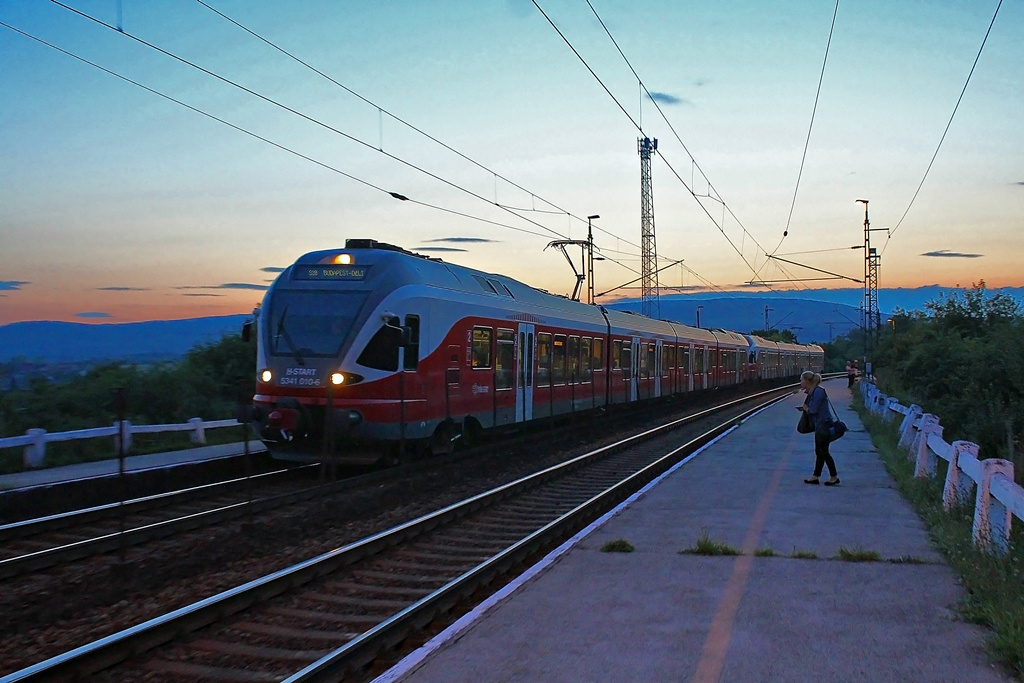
[{"x1": 0, "y1": 0, "x2": 1024, "y2": 324}]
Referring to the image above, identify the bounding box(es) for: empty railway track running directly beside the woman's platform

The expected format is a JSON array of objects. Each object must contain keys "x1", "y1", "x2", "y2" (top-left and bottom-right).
[{"x1": 0, "y1": 388, "x2": 792, "y2": 683}]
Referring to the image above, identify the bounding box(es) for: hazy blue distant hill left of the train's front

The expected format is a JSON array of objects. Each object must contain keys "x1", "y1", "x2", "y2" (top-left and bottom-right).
[{"x1": 0, "y1": 315, "x2": 249, "y2": 362}]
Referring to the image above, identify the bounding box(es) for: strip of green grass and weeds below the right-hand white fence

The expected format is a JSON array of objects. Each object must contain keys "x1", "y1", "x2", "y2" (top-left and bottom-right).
[{"x1": 853, "y1": 393, "x2": 1024, "y2": 677}]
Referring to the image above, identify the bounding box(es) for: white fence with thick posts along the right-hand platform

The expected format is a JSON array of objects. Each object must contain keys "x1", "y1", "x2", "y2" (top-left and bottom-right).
[{"x1": 860, "y1": 381, "x2": 1024, "y2": 555}]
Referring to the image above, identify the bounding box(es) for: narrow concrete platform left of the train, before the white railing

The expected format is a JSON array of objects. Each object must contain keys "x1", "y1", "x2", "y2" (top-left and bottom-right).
[{"x1": 0, "y1": 440, "x2": 266, "y2": 490}]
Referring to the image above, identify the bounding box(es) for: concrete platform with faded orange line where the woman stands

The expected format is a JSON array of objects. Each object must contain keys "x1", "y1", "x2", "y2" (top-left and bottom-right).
[{"x1": 378, "y1": 382, "x2": 1012, "y2": 683}]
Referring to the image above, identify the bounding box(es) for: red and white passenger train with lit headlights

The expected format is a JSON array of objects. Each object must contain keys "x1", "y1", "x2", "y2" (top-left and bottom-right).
[{"x1": 253, "y1": 240, "x2": 824, "y2": 462}]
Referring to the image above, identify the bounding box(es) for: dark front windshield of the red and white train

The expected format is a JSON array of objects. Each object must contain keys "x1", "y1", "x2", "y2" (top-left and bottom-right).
[{"x1": 267, "y1": 290, "x2": 369, "y2": 364}]
